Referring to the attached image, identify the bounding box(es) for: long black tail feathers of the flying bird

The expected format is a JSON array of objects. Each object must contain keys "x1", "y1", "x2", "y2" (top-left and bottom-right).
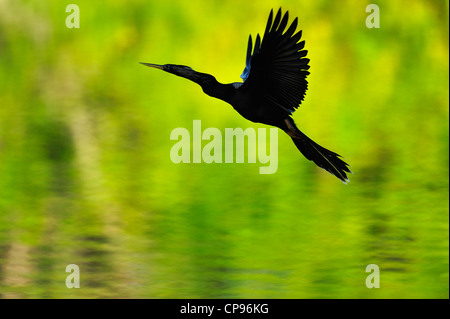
[{"x1": 286, "y1": 120, "x2": 352, "y2": 184}]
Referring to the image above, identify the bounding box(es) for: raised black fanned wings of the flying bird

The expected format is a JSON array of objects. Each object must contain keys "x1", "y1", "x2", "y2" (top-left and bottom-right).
[{"x1": 241, "y1": 8, "x2": 309, "y2": 115}]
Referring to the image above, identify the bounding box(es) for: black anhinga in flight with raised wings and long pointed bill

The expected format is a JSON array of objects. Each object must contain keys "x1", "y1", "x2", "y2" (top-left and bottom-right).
[{"x1": 142, "y1": 8, "x2": 351, "y2": 183}]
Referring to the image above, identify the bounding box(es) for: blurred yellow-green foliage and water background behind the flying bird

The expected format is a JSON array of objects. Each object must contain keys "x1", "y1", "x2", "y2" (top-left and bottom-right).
[{"x1": 0, "y1": 0, "x2": 449, "y2": 298}]
